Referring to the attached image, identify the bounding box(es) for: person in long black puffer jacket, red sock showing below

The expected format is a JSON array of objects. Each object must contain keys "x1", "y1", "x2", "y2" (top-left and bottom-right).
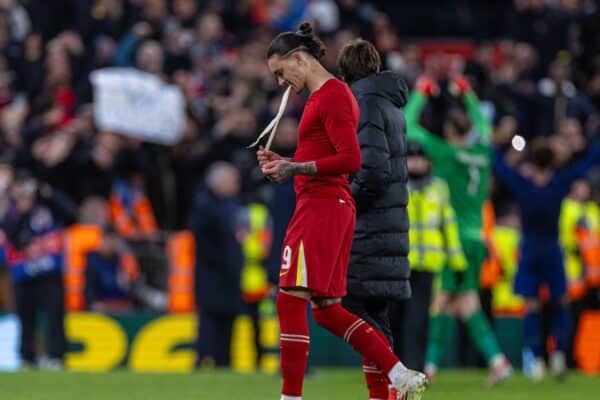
[{"x1": 338, "y1": 39, "x2": 410, "y2": 399}]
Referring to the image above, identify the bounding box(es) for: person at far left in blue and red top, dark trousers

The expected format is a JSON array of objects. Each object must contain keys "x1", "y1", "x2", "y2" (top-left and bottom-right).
[{"x1": 2, "y1": 171, "x2": 75, "y2": 369}]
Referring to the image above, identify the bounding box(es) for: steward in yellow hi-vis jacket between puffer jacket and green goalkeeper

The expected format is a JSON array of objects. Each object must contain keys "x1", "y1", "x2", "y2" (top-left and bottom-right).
[{"x1": 391, "y1": 142, "x2": 467, "y2": 371}]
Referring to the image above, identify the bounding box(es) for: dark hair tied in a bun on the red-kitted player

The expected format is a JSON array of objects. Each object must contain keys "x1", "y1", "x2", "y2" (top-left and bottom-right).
[{"x1": 267, "y1": 22, "x2": 325, "y2": 60}]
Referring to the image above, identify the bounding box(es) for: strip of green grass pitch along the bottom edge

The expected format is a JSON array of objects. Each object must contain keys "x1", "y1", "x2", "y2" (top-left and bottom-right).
[{"x1": 0, "y1": 368, "x2": 600, "y2": 400}]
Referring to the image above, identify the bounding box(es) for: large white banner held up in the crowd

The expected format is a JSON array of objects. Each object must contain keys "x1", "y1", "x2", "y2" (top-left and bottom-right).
[{"x1": 90, "y1": 68, "x2": 185, "y2": 145}]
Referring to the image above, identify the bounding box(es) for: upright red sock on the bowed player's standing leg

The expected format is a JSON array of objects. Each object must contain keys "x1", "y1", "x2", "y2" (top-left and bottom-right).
[{"x1": 276, "y1": 292, "x2": 310, "y2": 397}]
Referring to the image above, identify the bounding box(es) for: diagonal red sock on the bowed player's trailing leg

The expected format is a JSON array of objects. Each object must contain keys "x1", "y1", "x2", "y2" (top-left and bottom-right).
[{"x1": 313, "y1": 303, "x2": 399, "y2": 375}]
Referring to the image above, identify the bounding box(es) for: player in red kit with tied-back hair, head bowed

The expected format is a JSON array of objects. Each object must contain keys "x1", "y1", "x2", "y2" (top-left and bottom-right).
[{"x1": 258, "y1": 22, "x2": 427, "y2": 400}]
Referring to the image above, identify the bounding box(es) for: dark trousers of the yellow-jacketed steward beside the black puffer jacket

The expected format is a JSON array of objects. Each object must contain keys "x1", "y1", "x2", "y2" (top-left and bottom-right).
[{"x1": 390, "y1": 271, "x2": 434, "y2": 371}]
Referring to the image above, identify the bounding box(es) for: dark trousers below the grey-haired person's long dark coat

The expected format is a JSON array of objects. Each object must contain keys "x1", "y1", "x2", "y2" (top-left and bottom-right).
[{"x1": 196, "y1": 310, "x2": 235, "y2": 367}]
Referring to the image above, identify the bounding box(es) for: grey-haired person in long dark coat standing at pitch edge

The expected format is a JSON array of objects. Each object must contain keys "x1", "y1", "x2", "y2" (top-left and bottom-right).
[{"x1": 189, "y1": 162, "x2": 244, "y2": 367}]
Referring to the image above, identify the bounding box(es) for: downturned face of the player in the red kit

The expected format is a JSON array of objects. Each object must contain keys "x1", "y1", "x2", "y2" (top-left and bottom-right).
[{"x1": 267, "y1": 51, "x2": 310, "y2": 93}]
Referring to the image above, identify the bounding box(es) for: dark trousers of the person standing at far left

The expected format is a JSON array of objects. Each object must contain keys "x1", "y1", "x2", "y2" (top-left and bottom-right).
[{"x1": 15, "y1": 274, "x2": 65, "y2": 363}]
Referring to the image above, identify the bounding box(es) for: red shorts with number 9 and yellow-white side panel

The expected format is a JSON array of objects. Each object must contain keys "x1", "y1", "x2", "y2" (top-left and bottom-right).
[{"x1": 279, "y1": 197, "x2": 356, "y2": 297}]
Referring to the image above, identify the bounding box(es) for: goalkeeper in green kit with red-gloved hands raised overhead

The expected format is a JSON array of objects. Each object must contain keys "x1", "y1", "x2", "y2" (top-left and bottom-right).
[{"x1": 405, "y1": 76, "x2": 512, "y2": 385}]
